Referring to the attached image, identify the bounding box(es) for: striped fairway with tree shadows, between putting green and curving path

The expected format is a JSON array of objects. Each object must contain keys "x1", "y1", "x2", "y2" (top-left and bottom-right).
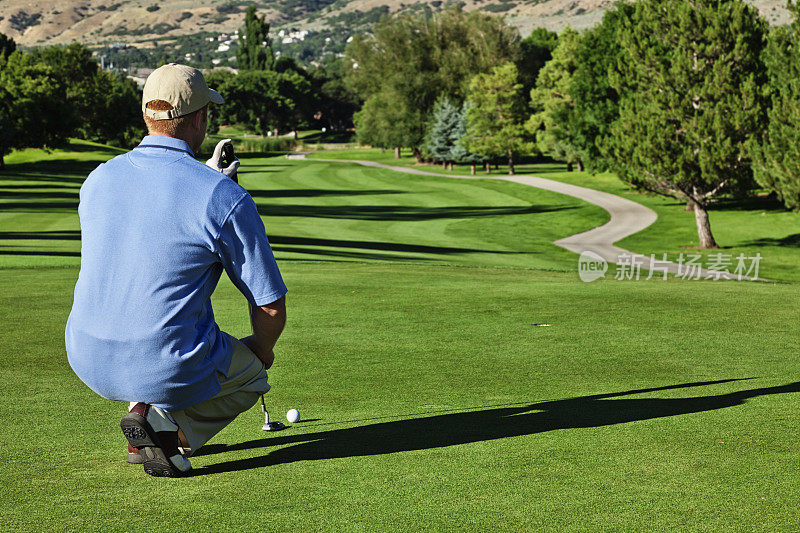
[{"x1": 0, "y1": 139, "x2": 608, "y2": 272}]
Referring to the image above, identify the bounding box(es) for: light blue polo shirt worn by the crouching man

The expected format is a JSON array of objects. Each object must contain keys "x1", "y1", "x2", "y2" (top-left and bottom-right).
[{"x1": 65, "y1": 135, "x2": 286, "y2": 411}]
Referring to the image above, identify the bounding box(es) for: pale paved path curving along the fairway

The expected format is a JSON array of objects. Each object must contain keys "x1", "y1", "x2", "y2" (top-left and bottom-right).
[{"x1": 286, "y1": 152, "x2": 750, "y2": 279}]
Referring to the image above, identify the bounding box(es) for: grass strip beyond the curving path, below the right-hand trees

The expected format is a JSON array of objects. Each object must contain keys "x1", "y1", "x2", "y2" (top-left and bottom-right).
[{"x1": 309, "y1": 149, "x2": 800, "y2": 281}]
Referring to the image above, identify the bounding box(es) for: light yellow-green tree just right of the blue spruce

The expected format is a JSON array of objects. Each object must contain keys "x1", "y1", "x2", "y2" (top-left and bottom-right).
[{"x1": 461, "y1": 62, "x2": 528, "y2": 174}]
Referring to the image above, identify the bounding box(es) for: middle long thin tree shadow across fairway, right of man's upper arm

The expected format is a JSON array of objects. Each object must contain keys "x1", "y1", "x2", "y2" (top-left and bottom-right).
[{"x1": 258, "y1": 204, "x2": 576, "y2": 221}]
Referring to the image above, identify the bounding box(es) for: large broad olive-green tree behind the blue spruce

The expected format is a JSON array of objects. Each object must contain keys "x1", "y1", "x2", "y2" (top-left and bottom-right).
[{"x1": 345, "y1": 8, "x2": 519, "y2": 159}]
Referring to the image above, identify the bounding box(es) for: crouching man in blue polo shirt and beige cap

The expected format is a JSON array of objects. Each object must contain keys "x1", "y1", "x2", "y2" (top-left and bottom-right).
[{"x1": 65, "y1": 64, "x2": 286, "y2": 476}]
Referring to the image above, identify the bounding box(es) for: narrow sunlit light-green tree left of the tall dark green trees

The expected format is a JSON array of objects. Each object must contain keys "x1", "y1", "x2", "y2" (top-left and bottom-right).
[{"x1": 525, "y1": 27, "x2": 583, "y2": 170}]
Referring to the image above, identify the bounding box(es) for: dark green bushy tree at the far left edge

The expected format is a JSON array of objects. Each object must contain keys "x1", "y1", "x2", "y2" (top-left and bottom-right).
[{"x1": 0, "y1": 50, "x2": 73, "y2": 168}]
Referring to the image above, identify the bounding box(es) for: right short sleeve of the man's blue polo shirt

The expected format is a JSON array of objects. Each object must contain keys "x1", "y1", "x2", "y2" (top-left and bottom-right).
[{"x1": 216, "y1": 195, "x2": 287, "y2": 306}]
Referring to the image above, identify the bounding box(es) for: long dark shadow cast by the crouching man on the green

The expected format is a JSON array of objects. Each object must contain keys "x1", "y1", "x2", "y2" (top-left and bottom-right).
[{"x1": 194, "y1": 379, "x2": 800, "y2": 475}]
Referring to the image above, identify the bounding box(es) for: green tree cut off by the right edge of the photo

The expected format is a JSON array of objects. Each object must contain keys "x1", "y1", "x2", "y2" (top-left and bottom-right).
[{"x1": 753, "y1": 2, "x2": 800, "y2": 210}]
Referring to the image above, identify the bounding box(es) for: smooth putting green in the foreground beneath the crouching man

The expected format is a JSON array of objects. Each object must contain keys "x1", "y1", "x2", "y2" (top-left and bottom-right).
[{"x1": 0, "y1": 261, "x2": 800, "y2": 531}]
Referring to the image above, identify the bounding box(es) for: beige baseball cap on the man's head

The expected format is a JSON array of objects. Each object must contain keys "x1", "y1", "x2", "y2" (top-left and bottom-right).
[{"x1": 142, "y1": 63, "x2": 224, "y2": 120}]
